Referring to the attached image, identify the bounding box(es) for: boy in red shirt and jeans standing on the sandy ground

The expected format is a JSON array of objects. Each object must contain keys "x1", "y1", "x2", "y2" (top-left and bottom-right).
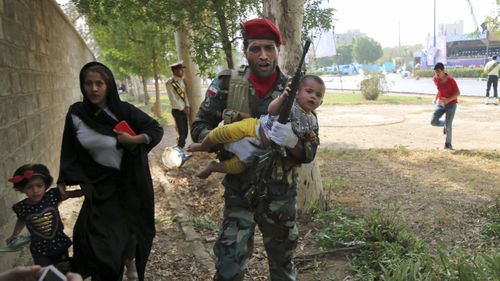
[{"x1": 431, "y1": 62, "x2": 460, "y2": 149}]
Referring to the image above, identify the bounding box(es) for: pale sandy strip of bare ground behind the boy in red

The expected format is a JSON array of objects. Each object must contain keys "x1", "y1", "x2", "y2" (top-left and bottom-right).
[{"x1": 318, "y1": 95, "x2": 500, "y2": 150}]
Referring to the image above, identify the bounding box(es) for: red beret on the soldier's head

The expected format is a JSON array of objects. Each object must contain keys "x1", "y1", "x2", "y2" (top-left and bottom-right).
[{"x1": 241, "y1": 19, "x2": 283, "y2": 47}]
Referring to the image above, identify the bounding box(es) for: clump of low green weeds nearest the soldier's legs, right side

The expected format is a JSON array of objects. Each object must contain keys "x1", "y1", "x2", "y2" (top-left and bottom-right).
[{"x1": 315, "y1": 203, "x2": 425, "y2": 280}]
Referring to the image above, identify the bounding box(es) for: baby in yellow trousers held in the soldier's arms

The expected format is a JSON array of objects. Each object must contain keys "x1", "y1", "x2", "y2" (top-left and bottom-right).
[{"x1": 187, "y1": 75, "x2": 325, "y2": 179}]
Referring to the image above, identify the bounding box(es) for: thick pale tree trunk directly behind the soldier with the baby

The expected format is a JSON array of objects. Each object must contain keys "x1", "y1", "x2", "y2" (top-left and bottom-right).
[{"x1": 264, "y1": 0, "x2": 324, "y2": 212}]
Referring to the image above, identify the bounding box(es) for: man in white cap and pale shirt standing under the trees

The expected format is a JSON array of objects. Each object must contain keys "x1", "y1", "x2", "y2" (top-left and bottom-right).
[{"x1": 166, "y1": 61, "x2": 189, "y2": 148}]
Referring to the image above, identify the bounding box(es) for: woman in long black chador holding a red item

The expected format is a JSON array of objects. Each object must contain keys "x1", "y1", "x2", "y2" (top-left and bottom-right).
[{"x1": 57, "y1": 62, "x2": 163, "y2": 281}]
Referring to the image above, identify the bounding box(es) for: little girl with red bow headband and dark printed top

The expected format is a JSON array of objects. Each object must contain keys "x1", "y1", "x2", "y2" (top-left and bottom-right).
[{"x1": 6, "y1": 164, "x2": 82, "y2": 266}]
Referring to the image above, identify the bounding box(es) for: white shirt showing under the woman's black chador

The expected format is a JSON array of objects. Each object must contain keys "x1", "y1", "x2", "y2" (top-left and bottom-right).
[{"x1": 71, "y1": 108, "x2": 123, "y2": 169}]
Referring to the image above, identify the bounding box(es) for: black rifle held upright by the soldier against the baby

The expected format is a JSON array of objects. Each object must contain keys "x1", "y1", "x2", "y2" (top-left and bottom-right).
[{"x1": 243, "y1": 39, "x2": 311, "y2": 207}]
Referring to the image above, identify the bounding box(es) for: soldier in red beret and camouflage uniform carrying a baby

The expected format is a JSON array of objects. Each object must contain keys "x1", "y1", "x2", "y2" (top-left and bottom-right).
[{"x1": 191, "y1": 19, "x2": 318, "y2": 281}]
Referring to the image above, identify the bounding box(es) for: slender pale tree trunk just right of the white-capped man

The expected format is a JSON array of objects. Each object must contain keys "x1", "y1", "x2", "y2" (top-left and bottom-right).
[{"x1": 175, "y1": 20, "x2": 203, "y2": 124}]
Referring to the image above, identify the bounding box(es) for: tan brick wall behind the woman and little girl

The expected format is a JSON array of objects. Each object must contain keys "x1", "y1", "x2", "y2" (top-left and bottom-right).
[{"x1": 0, "y1": 0, "x2": 93, "y2": 271}]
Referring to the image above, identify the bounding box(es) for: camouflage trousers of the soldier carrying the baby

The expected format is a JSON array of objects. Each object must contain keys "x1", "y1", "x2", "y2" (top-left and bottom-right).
[{"x1": 214, "y1": 185, "x2": 298, "y2": 281}]
